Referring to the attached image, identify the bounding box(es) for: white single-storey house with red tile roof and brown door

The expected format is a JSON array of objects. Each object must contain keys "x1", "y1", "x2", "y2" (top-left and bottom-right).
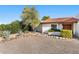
[{"x1": 39, "y1": 17, "x2": 79, "y2": 36}]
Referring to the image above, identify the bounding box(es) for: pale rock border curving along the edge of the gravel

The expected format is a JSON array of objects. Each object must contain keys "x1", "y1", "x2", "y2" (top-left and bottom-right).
[{"x1": 0, "y1": 32, "x2": 73, "y2": 41}]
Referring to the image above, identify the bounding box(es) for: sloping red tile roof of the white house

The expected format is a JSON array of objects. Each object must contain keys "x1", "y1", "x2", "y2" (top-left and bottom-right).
[{"x1": 41, "y1": 17, "x2": 79, "y2": 23}]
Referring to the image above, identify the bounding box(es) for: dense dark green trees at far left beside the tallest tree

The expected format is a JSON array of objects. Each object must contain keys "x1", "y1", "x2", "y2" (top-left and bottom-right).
[{"x1": 0, "y1": 20, "x2": 21, "y2": 33}]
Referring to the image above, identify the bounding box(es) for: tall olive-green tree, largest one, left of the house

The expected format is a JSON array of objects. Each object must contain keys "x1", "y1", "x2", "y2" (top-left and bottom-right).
[{"x1": 22, "y1": 6, "x2": 40, "y2": 31}]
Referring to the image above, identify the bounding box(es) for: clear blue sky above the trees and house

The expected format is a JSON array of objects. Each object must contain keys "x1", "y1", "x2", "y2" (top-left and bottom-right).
[{"x1": 0, "y1": 5, "x2": 79, "y2": 24}]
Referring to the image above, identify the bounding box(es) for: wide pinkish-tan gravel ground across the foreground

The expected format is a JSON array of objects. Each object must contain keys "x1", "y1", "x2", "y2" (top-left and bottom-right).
[{"x1": 0, "y1": 33, "x2": 79, "y2": 54}]
